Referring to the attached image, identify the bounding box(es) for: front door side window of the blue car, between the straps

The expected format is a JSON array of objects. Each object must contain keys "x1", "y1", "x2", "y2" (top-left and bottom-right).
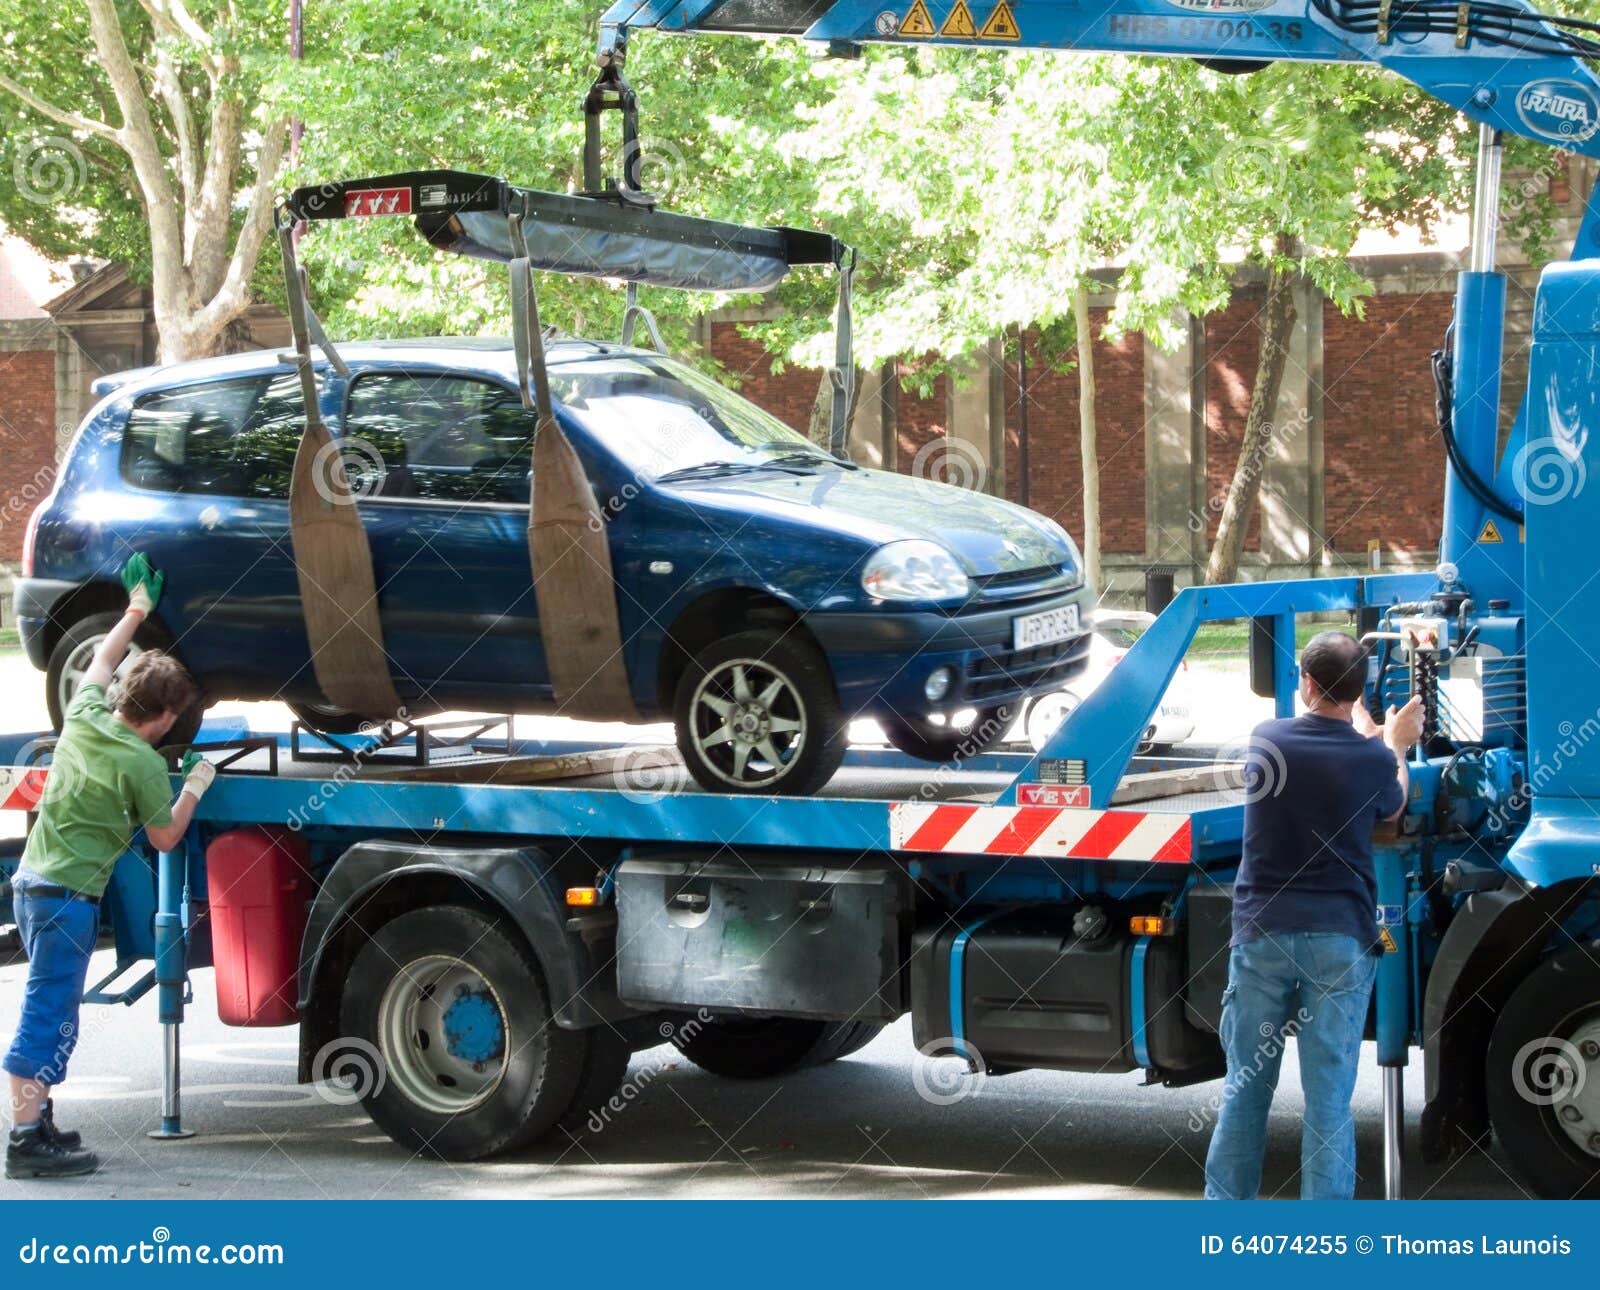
[{"x1": 342, "y1": 371, "x2": 534, "y2": 506}]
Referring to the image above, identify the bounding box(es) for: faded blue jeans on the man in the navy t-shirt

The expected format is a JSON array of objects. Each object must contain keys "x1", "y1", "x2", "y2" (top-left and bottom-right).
[{"x1": 1205, "y1": 931, "x2": 1378, "y2": 1200}]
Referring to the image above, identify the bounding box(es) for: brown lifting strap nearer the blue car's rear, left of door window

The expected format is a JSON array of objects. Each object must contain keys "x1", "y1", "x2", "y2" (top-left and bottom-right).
[{"x1": 277, "y1": 211, "x2": 402, "y2": 717}]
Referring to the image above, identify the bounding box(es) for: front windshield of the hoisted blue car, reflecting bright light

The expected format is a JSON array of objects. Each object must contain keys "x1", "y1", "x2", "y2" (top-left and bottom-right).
[{"x1": 550, "y1": 354, "x2": 832, "y2": 479}]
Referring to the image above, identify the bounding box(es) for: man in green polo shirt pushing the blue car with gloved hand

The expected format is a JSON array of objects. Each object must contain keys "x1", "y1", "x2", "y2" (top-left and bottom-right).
[{"x1": 0, "y1": 555, "x2": 216, "y2": 1178}]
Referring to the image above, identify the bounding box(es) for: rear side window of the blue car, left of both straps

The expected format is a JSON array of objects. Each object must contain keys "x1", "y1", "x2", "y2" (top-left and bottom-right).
[{"x1": 122, "y1": 373, "x2": 306, "y2": 498}]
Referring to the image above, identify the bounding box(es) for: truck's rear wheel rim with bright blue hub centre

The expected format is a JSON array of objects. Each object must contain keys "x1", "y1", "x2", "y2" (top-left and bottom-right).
[{"x1": 378, "y1": 954, "x2": 512, "y2": 1116}]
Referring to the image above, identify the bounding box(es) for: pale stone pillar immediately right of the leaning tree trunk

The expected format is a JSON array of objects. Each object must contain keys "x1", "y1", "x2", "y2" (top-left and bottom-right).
[{"x1": 1261, "y1": 278, "x2": 1323, "y2": 578}]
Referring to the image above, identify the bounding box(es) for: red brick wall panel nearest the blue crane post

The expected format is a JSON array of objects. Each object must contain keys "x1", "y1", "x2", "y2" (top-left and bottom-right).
[{"x1": 1322, "y1": 291, "x2": 1453, "y2": 552}]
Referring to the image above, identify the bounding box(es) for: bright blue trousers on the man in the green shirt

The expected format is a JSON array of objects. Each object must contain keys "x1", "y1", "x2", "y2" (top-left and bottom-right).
[{"x1": 0, "y1": 875, "x2": 99, "y2": 1085}]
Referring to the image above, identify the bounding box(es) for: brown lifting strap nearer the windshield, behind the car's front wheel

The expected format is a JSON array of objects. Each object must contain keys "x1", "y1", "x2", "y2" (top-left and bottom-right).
[{"x1": 507, "y1": 206, "x2": 638, "y2": 722}]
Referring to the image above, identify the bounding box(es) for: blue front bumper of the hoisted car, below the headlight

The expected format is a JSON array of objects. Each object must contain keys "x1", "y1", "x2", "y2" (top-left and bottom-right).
[{"x1": 805, "y1": 587, "x2": 1094, "y2": 717}]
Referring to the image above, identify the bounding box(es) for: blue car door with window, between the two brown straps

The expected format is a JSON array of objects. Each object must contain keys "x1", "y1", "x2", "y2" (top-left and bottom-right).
[{"x1": 341, "y1": 368, "x2": 549, "y2": 712}]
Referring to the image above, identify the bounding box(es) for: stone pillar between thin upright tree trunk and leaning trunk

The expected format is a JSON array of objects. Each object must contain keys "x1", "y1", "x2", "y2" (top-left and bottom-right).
[{"x1": 1144, "y1": 314, "x2": 1206, "y2": 578}]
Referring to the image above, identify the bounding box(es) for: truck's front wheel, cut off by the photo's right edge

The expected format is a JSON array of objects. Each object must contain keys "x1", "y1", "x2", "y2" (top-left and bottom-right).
[{"x1": 1485, "y1": 946, "x2": 1600, "y2": 1200}]
